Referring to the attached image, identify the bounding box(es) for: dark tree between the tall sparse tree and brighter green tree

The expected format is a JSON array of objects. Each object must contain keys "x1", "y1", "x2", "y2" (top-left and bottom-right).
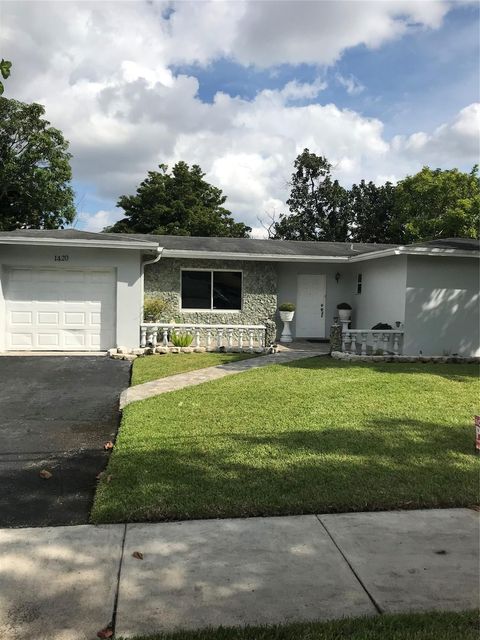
[{"x1": 348, "y1": 180, "x2": 404, "y2": 243}]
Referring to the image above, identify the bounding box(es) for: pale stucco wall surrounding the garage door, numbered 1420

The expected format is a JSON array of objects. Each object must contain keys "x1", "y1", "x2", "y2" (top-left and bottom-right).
[{"x1": 0, "y1": 245, "x2": 142, "y2": 351}]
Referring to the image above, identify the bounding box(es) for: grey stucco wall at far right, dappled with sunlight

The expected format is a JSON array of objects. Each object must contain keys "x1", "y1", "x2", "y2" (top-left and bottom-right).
[{"x1": 404, "y1": 256, "x2": 480, "y2": 356}]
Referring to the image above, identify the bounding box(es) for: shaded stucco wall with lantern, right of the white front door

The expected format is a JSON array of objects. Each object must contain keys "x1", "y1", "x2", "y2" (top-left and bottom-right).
[{"x1": 350, "y1": 256, "x2": 407, "y2": 329}]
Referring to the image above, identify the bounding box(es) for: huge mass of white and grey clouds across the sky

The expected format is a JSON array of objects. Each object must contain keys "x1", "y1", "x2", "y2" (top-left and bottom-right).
[{"x1": 2, "y1": 0, "x2": 478, "y2": 230}]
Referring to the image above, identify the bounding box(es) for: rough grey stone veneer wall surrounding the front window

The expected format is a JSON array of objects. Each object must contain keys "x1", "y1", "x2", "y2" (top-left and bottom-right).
[{"x1": 145, "y1": 258, "x2": 277, "y2": 324}]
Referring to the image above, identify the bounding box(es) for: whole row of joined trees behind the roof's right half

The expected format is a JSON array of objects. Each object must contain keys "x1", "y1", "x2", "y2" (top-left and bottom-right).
[{"x1": 272, "y1": 149, "x2": 480, "y2": 244}]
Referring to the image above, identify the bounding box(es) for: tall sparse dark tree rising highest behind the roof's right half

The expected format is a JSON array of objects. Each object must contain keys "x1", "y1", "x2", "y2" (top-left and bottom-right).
[{"x1": 273, "y1": 149, "x2": 349, "y2": 242}]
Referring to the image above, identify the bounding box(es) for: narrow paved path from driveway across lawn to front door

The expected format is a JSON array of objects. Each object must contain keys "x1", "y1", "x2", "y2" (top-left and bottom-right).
[{"x1": 120, "y1": 345, "x2": 329, "y2": 409}]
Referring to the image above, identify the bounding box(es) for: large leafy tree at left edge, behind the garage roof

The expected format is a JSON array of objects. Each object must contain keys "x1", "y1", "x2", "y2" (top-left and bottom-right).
[{"x1": 0, "y1": 97, "x2": 75, "y2": 231}]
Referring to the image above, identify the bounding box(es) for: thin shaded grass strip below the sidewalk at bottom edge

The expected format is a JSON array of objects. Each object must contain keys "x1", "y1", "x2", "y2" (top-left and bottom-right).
[{"x1": 119, "y1": 611, "x2": 479, "y2": 640}]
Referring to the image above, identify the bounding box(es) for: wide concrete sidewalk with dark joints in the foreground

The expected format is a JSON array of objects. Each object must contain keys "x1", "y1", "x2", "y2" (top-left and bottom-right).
[{"x1": 0, "y1": 509, "x2": 479, "y2": 640}]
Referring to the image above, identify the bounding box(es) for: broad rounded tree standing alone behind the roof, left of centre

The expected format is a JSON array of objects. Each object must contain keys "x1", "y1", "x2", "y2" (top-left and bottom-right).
[{"x1": 106, "y1": 162, "x2": 251, "y2": 238}]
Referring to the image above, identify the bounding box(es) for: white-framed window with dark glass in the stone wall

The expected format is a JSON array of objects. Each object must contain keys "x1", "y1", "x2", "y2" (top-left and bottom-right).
[{"x1": 182, "y1": 270, "x2": 242, "y2": 311}]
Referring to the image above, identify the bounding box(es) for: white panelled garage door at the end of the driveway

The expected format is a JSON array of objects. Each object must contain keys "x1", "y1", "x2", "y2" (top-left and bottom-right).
[{"x1": 5, "y1": 268, "x2": 116, "y2": 351}]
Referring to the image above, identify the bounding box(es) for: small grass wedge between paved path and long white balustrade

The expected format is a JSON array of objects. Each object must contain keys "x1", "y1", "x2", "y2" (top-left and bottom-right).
[{"x1": 132, "y1": 353, "x2": 258, "y2": 386}]
